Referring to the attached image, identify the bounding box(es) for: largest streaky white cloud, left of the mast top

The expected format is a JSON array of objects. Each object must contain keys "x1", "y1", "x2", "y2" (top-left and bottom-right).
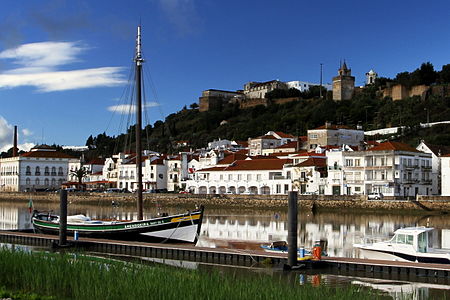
[{"x1": 0, "y1": 42, "x2": 125, "y2": 92}]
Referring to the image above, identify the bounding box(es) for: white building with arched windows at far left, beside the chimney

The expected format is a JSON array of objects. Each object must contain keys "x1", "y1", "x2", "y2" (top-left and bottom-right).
[{"x1": 0, "y1": 145, "x2": 79, "y2": 191}]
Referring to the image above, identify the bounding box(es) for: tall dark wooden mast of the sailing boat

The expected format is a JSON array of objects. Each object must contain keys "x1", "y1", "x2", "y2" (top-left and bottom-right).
[{"x1": 134, "y1": 25, "x2": 144, "y2": 220}]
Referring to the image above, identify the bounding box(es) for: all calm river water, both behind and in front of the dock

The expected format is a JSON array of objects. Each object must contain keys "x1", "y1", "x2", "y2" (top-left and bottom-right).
[{"x1": 0, "y1": 202, "x2": 450, "y2": 299}]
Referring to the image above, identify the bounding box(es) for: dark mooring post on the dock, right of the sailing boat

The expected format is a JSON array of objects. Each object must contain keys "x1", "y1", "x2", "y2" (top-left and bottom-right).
[{"x1": 288, "y1": 191, "x2": 298, "y2": 268}]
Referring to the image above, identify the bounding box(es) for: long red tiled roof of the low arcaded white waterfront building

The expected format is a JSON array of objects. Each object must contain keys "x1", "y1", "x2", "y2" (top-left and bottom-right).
[{"x1": 200, "y1": 158, "x2": 292, "y2": 172}]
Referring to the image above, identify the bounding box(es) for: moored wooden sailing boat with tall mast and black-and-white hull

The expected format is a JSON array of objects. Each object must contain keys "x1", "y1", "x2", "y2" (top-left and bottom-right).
[{"x1": 32, "y1": 26, "x2": 203, "y2": 244}]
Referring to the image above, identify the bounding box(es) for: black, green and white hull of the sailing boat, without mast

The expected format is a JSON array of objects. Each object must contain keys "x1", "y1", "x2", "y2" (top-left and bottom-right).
[{"x1": 32, "y1": 207, "x2": 203, "y2": 244}]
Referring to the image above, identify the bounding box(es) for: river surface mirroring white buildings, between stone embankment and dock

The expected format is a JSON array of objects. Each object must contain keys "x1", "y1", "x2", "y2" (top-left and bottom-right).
[{"x1": 0, "y1": 203, "x2": 450, "y2": 257}]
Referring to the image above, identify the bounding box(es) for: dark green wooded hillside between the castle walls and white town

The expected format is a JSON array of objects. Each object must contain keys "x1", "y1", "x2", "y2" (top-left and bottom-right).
[{"x1": 79, "y1": 83, "x2": 450, "y2": 161}]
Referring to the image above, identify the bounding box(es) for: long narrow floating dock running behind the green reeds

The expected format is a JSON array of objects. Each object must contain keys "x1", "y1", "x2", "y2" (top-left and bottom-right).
[{"x1": 0, "y1": 231, "x2": 450, "y2": 278}]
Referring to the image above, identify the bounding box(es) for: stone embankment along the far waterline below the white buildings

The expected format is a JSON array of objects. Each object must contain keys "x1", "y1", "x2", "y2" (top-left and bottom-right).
[{"x1": 0, "y1": 192, "x2": 450, "y2": 213}]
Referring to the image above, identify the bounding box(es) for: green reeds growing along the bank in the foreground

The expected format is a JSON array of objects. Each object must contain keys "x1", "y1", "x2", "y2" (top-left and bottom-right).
[{"x1": 0, "y1": 248, "x2": 380, "y2": 300}]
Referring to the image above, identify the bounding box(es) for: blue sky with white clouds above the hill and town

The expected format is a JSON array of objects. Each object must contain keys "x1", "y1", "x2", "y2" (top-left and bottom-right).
[{"x1": 0, "y1": 0, "x2": 450, "y2": 151}]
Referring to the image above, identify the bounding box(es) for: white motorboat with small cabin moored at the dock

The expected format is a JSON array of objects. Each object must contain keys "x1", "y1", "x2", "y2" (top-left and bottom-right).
[{"x1": 353, "y1": 227, "x2": 450, "y2": 264}]
